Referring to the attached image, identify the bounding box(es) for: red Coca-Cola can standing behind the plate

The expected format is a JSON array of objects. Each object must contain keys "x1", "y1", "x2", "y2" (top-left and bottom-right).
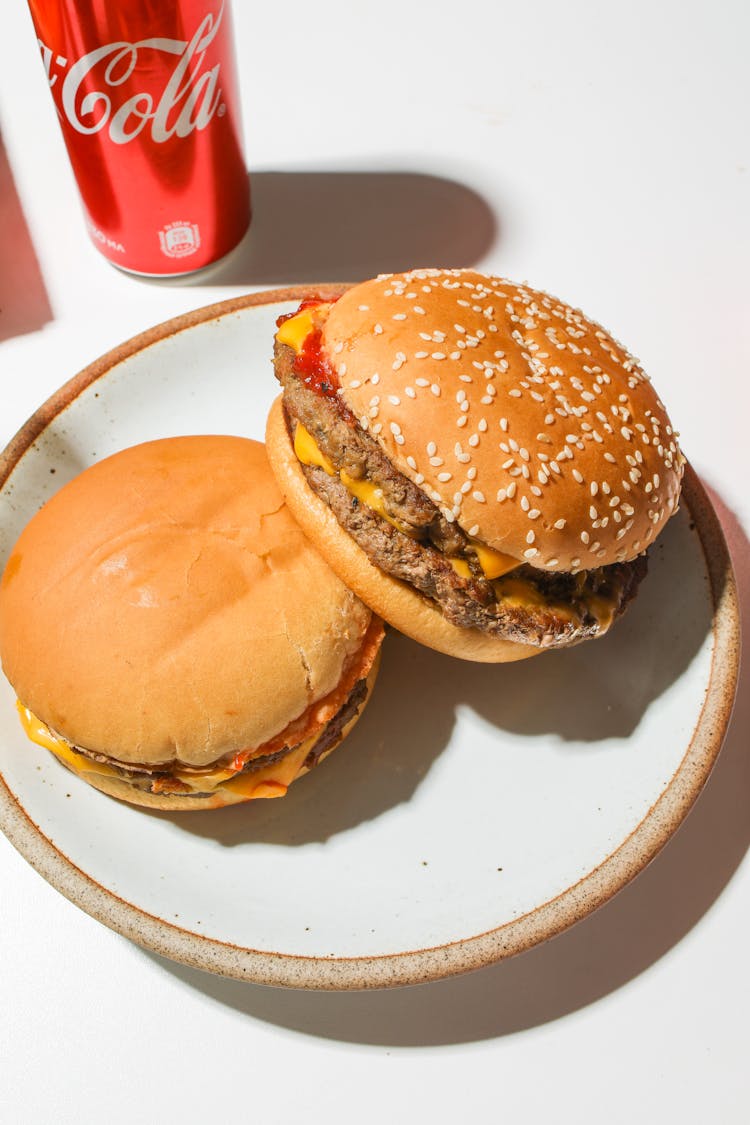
[{"x1": 29, "y1": 0, "x2": 250, "y2": 277}]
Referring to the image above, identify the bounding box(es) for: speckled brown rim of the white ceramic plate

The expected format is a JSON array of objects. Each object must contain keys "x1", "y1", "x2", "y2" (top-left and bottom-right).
[{"x1": 0, "y1": 284, "x2": 740, "y2": 990}]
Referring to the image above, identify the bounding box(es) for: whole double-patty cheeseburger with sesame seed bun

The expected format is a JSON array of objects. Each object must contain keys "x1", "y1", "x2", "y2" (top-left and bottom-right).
[{"x1": 266, "y1": 269, "x2": 684, "y2": 662}]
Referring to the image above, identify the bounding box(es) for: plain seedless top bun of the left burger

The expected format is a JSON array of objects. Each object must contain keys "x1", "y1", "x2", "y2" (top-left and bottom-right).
[{"x1": 0, "y1": 437, "x2": 371, "y2": 766}]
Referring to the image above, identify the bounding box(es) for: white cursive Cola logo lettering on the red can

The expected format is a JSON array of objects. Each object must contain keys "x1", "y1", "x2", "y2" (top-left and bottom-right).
[{"x1": 39, "y1": 5, "x2": 225, "y2": 144}]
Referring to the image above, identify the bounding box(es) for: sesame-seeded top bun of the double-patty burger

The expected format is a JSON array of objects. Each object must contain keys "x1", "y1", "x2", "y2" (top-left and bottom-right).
[{"x1": 323, "y1": 270, "x2": 684, "y2": 570}]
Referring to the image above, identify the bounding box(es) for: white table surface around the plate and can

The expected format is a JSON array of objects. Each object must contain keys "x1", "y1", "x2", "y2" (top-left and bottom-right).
[{"x1": 0, "y1": 0, "x2": 750, "y2": 1125}]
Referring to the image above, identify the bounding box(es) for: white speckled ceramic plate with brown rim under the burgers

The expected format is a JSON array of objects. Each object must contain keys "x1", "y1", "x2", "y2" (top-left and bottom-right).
[{"x1": 0, "y1": 289, "x2": 738, "y2": 989}]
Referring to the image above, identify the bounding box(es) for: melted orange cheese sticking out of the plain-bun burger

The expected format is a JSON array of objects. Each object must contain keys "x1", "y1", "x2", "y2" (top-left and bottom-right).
[{"x1": 16, "y1": 702, "x2": 320, "y2": 798}]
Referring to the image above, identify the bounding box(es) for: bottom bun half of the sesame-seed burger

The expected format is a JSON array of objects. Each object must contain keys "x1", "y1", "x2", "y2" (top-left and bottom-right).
[{"x1": 265, "y1": 397, "x2": 543, "y2": 664}]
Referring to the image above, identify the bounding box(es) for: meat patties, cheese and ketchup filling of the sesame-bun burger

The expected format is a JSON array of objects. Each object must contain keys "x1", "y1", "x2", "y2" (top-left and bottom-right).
[{"x1": 274, "y1": 300, "x2": 647, "y2": 647}]
